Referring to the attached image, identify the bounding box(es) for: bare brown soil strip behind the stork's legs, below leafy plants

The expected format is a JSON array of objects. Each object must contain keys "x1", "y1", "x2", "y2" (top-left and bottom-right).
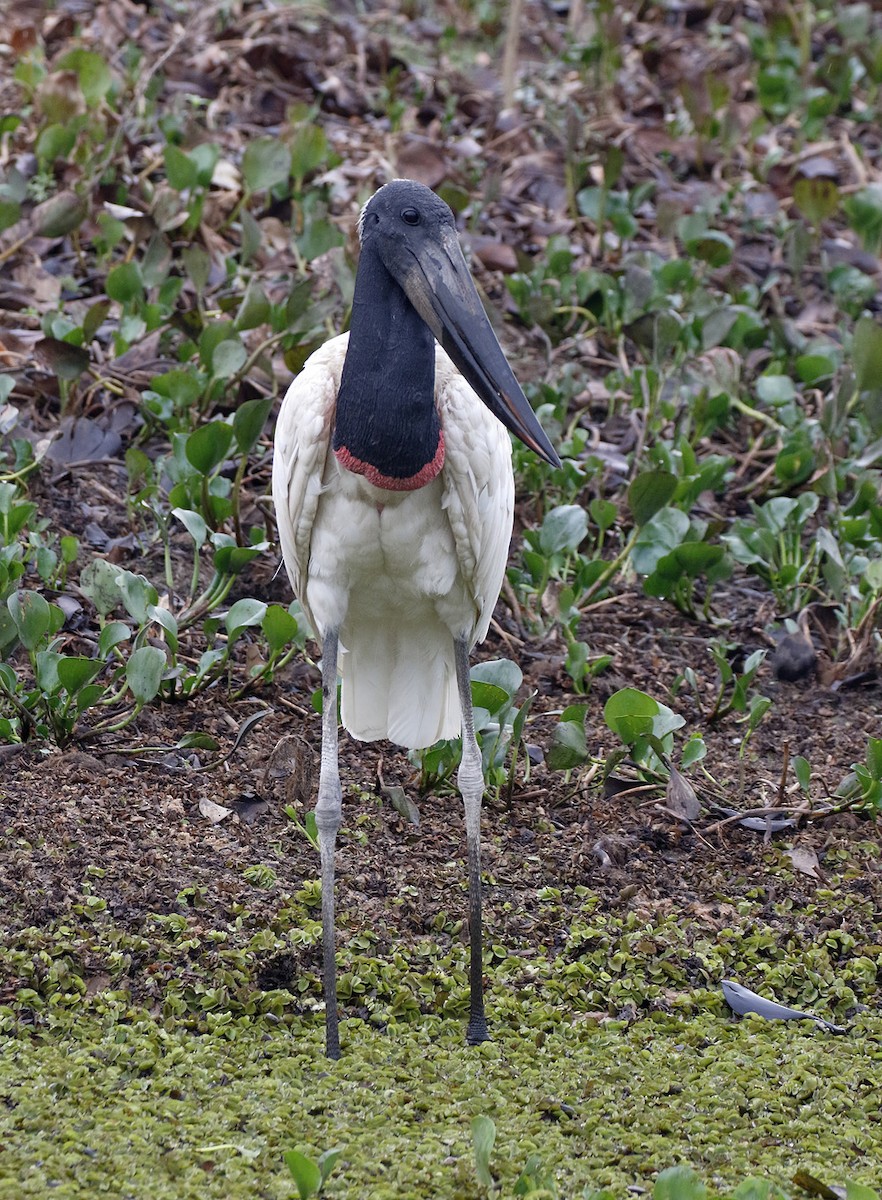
[{"x1": 0, "y1": 556, "x2": 882, "y2": 1017}]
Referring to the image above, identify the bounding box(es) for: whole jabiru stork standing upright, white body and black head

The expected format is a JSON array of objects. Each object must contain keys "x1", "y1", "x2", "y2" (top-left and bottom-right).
[{"x1": 272, "y1": 179, "x2": 560, "y2": 1058}]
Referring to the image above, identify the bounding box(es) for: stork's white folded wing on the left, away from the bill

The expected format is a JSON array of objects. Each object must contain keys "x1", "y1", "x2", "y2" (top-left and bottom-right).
[{"x1": 272, "y1": 334, "x2": 349, "y2": 634}]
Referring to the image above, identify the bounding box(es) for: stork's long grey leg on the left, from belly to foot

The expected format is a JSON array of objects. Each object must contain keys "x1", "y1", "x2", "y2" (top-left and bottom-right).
[{"x1": 316, "y1": 629, "x2": 342, "y2": 1058}]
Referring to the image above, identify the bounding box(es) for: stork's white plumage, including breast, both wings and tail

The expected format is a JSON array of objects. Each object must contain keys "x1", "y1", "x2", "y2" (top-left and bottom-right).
[{"x1": 272, "y1": 334, "x2": 515, "y2": 748}]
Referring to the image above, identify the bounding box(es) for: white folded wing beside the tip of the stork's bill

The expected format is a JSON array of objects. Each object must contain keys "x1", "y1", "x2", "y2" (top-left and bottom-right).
[{"x1": 436, "y1": 348, "x2": 515, "y2": 646}]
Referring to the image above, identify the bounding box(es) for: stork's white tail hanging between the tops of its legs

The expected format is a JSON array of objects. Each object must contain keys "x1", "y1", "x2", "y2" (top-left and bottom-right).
[{"x1": 340, "y1": 622, "x2": 461, "y2": 750}]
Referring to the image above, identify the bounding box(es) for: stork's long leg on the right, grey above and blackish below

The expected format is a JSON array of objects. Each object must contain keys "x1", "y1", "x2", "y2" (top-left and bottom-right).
[{"x1": 456, "y1": 641, "x2": 490, "y2": 1045}]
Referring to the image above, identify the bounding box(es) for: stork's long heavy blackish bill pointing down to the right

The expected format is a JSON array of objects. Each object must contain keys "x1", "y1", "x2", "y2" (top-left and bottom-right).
[{"x1": 396, "y1": 229, "x2": 560, "y2": 467}]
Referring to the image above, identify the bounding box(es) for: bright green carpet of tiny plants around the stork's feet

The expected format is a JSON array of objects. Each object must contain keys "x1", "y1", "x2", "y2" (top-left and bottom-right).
[{"x1": 0, "y1": 1004, "x2": 882, "y2": 1200}]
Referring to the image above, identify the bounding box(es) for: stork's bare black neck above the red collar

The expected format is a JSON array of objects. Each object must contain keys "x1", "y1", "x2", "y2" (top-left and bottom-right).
[{"x1": 334, "y1": 244, "x2": 440, "y2": 480}]
